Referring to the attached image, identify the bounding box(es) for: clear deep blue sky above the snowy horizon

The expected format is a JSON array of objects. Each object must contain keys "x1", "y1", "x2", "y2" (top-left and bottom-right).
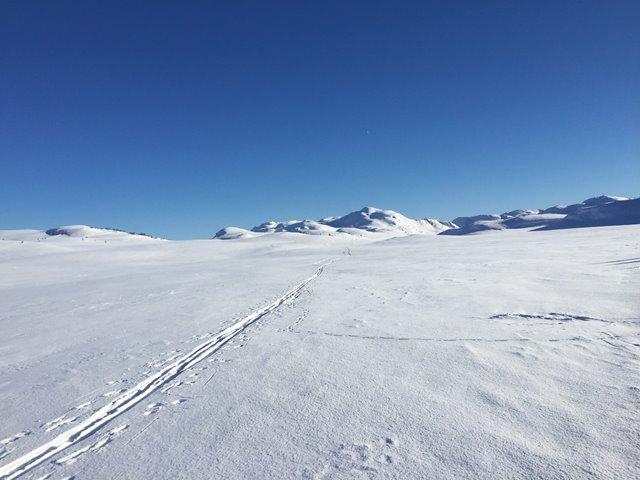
[{"x1": 0, "y1": 0, "x2": 640, "y2": 238}]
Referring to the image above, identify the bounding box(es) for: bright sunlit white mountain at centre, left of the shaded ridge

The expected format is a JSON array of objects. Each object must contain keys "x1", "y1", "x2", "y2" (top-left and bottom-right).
[{"x1": 214, "y1": 207, "x2": 454, "y2": 240}]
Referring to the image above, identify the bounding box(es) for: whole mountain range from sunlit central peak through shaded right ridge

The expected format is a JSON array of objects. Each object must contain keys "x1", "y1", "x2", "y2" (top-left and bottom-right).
[{"x1": 214, "y1": 195, "x2": 640, "y2": 240}]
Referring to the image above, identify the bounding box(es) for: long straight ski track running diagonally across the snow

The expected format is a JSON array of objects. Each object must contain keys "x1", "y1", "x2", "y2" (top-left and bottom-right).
[{"x1": 0, "y1": 260, "x2": 333, "y2": 480}]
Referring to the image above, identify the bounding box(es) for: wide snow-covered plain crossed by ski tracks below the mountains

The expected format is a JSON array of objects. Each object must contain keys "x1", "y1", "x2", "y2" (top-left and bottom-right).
[{"x1": 0, "y1": 226, "x2": 640, "y2": 480}]
